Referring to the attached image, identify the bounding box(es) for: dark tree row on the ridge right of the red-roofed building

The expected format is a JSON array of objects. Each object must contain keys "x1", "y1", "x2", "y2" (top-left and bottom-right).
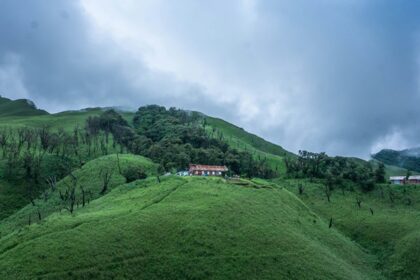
[{"x1": 286, "y1": 151, "x2": 385, "y2": 192}]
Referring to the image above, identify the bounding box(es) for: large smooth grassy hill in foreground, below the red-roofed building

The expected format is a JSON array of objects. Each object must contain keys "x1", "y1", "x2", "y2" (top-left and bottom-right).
[{"x1": 0, "y1": 177, "x2": 377, "y2": 279}]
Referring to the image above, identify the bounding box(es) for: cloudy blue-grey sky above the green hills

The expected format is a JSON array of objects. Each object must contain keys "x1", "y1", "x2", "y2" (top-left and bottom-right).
[{"x1": 0, "y1": 0, "x2": 420, "y2": 158}]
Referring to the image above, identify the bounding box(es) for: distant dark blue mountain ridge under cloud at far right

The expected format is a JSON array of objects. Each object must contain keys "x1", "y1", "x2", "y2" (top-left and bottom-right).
[{"x1": 372, "y1": 147, "x2": 420, "y2": 172}]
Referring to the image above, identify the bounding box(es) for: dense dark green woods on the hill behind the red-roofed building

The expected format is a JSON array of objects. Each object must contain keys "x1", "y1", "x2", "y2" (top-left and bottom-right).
[{"x1": 86, "y1": 105, "x2": 276, "y2": 178}]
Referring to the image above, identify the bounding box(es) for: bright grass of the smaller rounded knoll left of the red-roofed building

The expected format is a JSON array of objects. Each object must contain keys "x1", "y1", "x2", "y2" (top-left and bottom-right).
[{"x1": 0, "y1": 155, "x2": 157, "y2": 236}]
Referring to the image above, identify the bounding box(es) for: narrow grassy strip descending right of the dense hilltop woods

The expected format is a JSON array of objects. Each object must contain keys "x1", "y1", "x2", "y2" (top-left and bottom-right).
[{"x1": 206, "y1": 117, "x2": 293, "y2": 173}]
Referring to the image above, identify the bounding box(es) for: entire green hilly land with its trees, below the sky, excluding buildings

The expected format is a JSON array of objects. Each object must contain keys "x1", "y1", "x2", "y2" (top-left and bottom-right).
[{"x1": 0, "y1": 97, "x2": 420, "y2": 279}]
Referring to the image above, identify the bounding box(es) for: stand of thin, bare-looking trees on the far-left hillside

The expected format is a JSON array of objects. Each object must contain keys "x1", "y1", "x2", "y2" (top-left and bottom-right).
[{"x1": 0, "y1": 122, "x2": 124, "y2": 201}]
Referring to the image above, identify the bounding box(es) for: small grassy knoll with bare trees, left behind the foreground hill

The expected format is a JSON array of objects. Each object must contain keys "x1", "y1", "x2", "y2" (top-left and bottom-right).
[{"x1": 0, "y1": 154, "x2": 157, "y2": 236}]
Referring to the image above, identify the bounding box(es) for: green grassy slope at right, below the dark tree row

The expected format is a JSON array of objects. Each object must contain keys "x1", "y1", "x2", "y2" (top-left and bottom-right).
[{"x1": 278, "y1": 180, "x2": 420, "y2": 279}]
